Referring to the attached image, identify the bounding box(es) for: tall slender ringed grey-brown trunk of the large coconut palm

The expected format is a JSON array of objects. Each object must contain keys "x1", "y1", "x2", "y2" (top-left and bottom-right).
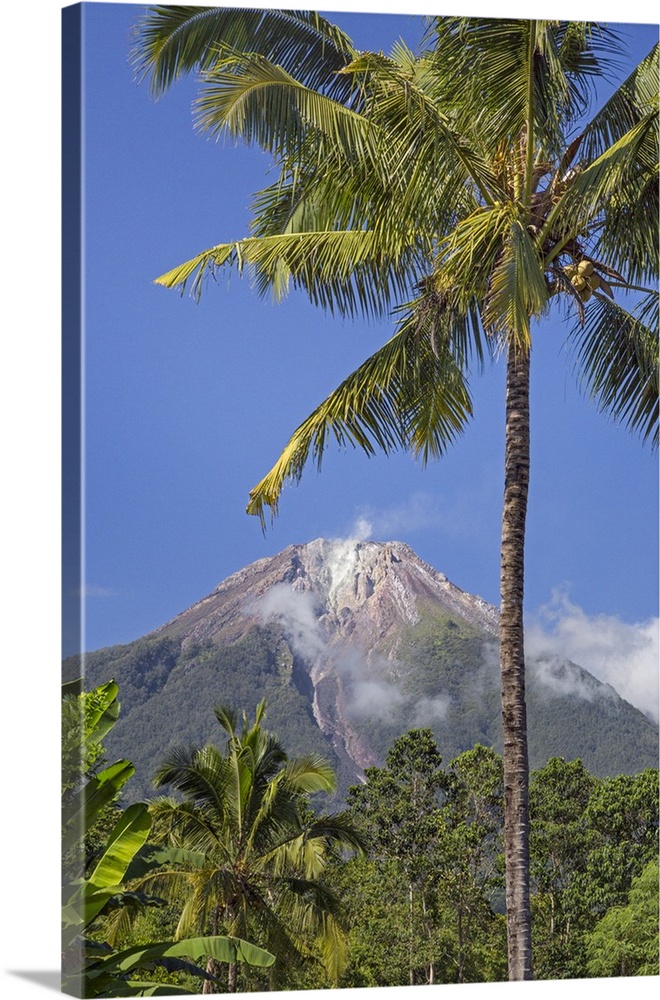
[{"x1": 500, "y1": 345, "x2": 532, "y2": 980}]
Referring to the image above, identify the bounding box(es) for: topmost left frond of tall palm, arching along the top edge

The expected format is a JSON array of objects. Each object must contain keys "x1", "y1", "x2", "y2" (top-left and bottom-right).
[{"x1": 131, "y1": 5, "x2": 354, "y2": 98}]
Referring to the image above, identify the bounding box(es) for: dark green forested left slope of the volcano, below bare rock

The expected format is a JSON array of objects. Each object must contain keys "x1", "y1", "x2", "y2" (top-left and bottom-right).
[{"x1": 81, "y1": 625, "x2": 336, "y2": 802}]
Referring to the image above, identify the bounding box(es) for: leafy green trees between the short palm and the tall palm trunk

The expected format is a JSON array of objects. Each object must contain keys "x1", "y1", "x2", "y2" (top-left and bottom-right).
[{"x1": 343, "y1": 729, "x2": 506, "y2": 986}]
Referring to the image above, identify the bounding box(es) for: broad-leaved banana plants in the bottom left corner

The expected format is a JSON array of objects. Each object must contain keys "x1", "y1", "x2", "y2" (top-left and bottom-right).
[{"x1": 62, "y1": 682, "x2": 274, "y2": 997}]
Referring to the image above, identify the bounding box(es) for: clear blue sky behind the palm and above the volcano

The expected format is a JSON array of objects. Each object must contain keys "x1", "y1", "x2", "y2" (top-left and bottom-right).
[{"x1": 71, "y1": 4, "x2": 658, "y2": 684}]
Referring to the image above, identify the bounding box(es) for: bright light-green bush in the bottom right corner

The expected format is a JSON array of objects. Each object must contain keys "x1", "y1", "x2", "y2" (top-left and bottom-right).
[{"x1": 587, "y1": 860, "x2": 660, "y2": 976}]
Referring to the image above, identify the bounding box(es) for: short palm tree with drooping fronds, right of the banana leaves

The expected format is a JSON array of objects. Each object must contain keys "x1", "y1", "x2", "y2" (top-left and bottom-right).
[{"x1": 140, "y1": 702, "x2": 362, "y2": 993}]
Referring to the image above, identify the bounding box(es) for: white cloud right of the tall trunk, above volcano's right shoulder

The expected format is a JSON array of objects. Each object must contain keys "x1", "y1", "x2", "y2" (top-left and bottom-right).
[{"x1": 525, "y1": 588, "x2": 660, "y2": 722}]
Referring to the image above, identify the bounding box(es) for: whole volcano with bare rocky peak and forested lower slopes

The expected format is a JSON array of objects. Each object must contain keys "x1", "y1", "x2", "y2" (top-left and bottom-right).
[{"x1": 65, "y1": 539, "x2": 658, "y2": 799}]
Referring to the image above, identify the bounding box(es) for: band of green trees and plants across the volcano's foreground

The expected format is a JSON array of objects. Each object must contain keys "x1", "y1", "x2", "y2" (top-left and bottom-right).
[{"x1": 63, "y1": 682, "x2": 659, "y2": 997}]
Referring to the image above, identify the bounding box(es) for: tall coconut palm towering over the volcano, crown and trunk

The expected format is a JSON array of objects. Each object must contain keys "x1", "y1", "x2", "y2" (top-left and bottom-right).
[{"x1": 135, "y1": 8, "x2": 658, "y2": 979}]
